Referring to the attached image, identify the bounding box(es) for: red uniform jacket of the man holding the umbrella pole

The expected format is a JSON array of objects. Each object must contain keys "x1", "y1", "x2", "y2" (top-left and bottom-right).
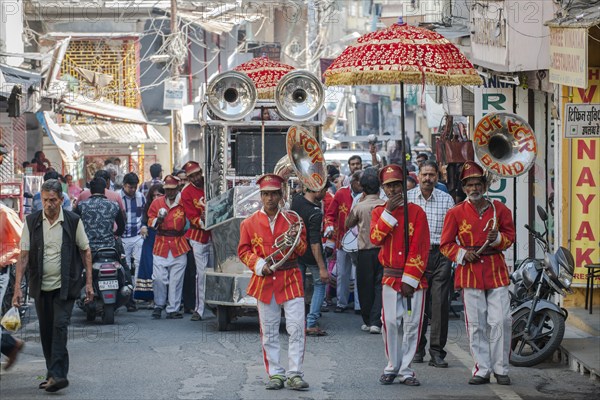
[{"x1": 371, "y1": 203, "x2": 430, "y2": 292}]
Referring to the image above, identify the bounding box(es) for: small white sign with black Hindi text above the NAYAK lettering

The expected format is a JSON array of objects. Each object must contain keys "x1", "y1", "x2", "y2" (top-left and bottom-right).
[{"x1": 565, "y1": 103, "x2": 600, "y2": 139}]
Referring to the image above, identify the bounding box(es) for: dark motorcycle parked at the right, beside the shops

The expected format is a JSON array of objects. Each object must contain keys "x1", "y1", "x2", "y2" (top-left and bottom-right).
[{"x1": 510, "y1": 206, "x2": 575, "y2": 367}]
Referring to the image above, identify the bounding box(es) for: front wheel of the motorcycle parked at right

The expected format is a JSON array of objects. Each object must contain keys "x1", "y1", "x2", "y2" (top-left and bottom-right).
[{"x1": 510, "y1": 309, "x2": 565, "y2": 367}]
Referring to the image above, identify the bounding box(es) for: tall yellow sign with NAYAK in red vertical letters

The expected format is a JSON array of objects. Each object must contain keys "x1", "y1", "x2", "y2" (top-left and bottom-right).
[{"x1": 561, "y1": 68, "x2": 600, "y2": 286}]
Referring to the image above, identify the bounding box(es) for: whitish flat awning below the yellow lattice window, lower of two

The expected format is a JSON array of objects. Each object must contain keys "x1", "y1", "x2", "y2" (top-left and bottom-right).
[{"x1": 70, "y1": 123, "x2": 167, "y2": 144}]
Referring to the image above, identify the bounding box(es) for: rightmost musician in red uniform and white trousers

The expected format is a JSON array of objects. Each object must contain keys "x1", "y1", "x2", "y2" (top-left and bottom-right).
[{"x1": 440, "y1": 161, "x2": 515, "y2": 385}]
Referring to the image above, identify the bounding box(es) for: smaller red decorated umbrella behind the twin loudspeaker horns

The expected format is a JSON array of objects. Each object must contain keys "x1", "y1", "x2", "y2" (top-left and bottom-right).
[{"x1": 233, "y1": 56, "x2": 294, "y2": 99}]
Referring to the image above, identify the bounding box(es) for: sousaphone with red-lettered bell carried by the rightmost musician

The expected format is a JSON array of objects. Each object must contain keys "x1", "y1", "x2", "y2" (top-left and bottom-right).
[{"x1": 473, "y1": 112, "x2": 537, "y2": 255}]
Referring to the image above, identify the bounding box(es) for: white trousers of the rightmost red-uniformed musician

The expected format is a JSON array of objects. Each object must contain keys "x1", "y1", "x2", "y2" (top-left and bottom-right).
[{"x1": 463, "y1": 286, "x2": 512, "y2": 378}]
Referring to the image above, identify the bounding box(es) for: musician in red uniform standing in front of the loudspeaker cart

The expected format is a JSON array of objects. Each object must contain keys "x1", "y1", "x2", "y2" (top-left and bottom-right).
[{"x1": 238, "y1": 174, "x2": 308, "y2": 390}]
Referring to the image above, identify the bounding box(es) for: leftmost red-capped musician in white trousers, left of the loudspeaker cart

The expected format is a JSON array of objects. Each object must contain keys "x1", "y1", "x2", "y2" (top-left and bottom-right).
[{"x1": 148, "y1": 175, "x2": 190, "y2": 319}]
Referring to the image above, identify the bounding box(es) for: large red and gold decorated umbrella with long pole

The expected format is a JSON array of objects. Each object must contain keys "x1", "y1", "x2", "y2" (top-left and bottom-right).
[{"x1": 323, "y1": 18, "x2": 483, "y2": 300}]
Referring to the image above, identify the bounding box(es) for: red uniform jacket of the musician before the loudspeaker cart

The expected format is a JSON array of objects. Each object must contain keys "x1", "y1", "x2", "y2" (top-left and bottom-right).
[{"x1": 238, "y1": 210, "x2": 307, "y2": 304}]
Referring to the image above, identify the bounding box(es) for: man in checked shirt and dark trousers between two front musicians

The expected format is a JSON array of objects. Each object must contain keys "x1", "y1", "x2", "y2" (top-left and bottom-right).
[{"x1": 407, "y1": 160, "x2": 454, "y2": 368}]
